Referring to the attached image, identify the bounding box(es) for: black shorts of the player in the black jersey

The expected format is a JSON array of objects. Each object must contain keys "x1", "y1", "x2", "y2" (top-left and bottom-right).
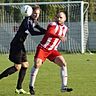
[{"x1": 9, "y1": 46, "x2": 27, "y2": 64}]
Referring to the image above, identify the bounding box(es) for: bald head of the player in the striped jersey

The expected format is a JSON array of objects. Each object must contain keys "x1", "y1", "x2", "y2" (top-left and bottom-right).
[{"x1": 55, "y1": 11, "x2": 66, "y2": 24}]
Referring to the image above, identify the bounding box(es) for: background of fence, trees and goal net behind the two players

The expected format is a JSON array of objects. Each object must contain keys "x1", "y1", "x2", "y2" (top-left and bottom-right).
[{"x1": 0, "y1": 0, "x2": 96, "y2": 53}]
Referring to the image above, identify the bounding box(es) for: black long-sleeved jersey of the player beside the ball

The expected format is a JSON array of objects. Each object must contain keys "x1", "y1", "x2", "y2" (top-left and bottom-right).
[{"x1": 11, "y1": 17, "x2": 46, "y2": 45}]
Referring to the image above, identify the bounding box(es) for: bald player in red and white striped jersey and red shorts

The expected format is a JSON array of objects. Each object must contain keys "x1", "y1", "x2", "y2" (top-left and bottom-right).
[{"x1": 29, "y1": 11, "x2": 73, "y2": 95}]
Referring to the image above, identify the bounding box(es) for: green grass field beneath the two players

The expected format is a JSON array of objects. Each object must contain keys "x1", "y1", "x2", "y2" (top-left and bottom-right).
[{"x1": 0, "y1": 54, "x2": 96, "y2": 96}]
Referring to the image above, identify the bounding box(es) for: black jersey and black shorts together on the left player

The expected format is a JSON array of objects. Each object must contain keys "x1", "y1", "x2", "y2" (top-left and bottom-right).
[{"x1": 9, "y1": 17, "x2": 46, "y2": 64}]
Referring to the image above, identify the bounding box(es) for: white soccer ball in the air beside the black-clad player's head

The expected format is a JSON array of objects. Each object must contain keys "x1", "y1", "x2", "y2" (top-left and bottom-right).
[{"x1": 21, "y1": 5, "x2": 33, "y2": 16}]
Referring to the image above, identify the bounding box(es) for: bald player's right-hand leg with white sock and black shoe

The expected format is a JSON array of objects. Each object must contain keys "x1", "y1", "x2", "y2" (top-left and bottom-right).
[{"x1": 50, "y1": 51, "x2": 72, "y2": 92}]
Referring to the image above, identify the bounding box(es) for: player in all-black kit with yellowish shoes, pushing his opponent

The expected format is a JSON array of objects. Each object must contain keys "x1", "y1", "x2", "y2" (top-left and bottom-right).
[{"x1": 0, "y1": 5, "x2": 46, "y2": 94}]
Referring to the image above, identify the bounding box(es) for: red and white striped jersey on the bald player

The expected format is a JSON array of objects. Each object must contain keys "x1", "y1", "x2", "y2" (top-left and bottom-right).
[{"x1": 40, "y1": 22, "x2": 68, "y2": 50}]
